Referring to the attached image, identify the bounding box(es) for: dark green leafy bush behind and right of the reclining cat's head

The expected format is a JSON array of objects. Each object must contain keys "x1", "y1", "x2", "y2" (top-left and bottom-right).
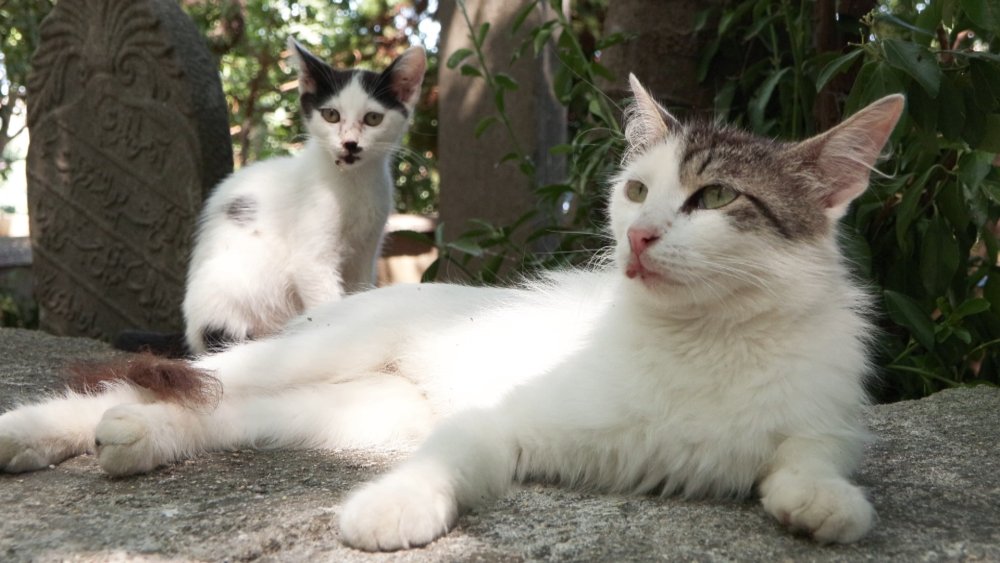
[{"x1": 702, "y1": 0, "x2": 1000, "y2": 400}]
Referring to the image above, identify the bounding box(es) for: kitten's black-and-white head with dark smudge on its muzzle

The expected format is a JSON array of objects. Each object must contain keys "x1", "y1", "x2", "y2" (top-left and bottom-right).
[{"x1": 288, "y1": 39, "x2": 427, "y2": 167}]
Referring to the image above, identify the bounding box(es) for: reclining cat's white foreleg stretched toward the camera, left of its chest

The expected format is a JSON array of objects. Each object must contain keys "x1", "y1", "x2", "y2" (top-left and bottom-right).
[{"x1": 340, "y1": 410, "x2": 517, "y2": 551}]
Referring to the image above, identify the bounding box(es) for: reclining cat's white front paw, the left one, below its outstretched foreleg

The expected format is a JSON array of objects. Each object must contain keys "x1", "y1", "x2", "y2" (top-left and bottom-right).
[{"x1": 340, "y1": 470, "x2": 458, "y2": 551}]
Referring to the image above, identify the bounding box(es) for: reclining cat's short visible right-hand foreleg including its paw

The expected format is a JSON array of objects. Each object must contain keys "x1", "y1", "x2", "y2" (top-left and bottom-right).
[{"x1": 760, "y1": 437, "x2": 875, "y2": 543}]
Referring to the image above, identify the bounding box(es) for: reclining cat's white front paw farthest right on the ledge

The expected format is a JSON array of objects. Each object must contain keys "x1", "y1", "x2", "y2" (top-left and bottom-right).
[{"x1": 761, "y1": 474, "x2": 875, "y2": 543}]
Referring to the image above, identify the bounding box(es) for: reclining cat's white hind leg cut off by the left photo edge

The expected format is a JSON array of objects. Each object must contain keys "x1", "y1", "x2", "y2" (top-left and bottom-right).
[{"x1": 0, "y1": 385, "x2": 139, "y2": 473}]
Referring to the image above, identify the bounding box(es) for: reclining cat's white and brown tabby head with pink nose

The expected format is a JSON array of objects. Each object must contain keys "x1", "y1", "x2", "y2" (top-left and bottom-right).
[{"x1": 610, "y1": 76, "x2": 903, "y2": 308}]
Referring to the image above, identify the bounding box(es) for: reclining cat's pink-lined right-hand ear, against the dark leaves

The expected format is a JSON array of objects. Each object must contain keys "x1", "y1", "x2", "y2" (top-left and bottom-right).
[{"x1": 793, "y1": 94, "x2": 905, "y2": 219}]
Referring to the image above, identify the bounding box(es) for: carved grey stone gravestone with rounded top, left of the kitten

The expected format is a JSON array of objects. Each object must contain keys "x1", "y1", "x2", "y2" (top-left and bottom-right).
[{"x1": 28, "y1": 0, "x2": 232, "y2": 340}]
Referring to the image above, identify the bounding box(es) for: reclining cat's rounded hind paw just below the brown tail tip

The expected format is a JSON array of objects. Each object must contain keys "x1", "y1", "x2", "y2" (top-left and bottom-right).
[{"x1": 95, "y1": 405, "x2": 159, "y2": 476}]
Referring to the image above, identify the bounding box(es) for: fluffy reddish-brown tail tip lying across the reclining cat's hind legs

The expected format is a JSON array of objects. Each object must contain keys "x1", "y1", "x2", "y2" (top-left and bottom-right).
[{"x1": 69, "y1": 354, "x2": 222, "y2": 408}]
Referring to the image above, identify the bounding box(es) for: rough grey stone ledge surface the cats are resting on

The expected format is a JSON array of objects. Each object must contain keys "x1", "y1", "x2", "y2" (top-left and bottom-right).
[{"x1": 0, "y1": 329, "x2": 1000, "y2": 562}]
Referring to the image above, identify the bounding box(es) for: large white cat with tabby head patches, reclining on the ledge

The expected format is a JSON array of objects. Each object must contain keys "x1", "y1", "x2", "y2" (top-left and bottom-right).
[{"x1": 0, "y1": 77, "x2": 903, "y2": 550}]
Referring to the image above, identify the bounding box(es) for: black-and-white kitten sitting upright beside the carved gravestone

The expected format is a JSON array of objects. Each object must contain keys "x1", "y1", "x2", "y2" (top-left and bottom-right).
[{"x1": 184, "y1": 40, "x2": 427, "y2": 353}]
